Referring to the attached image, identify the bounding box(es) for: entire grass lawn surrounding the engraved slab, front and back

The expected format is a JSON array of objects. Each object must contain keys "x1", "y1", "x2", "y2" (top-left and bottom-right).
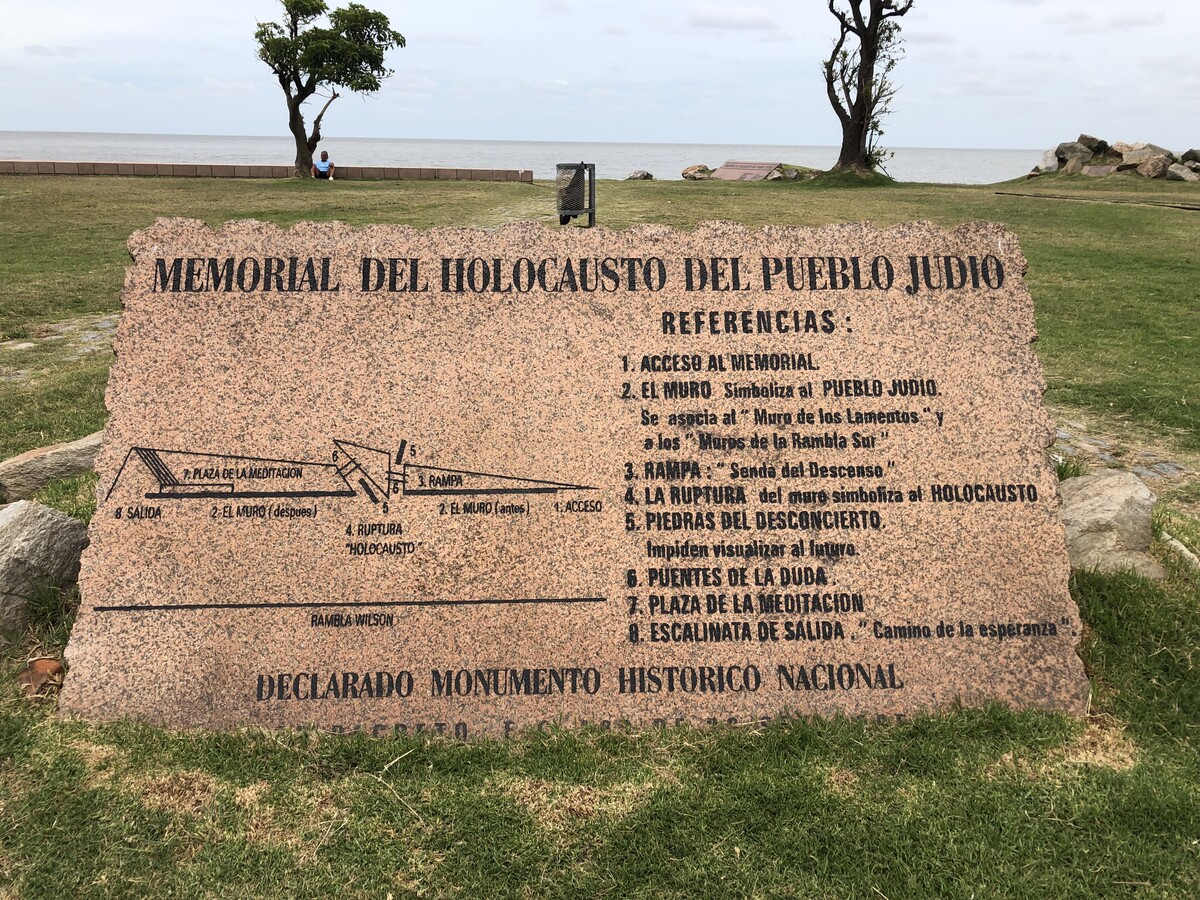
[{"x1": 0, "y1": 176, "x2": 1200, "y2": 900}]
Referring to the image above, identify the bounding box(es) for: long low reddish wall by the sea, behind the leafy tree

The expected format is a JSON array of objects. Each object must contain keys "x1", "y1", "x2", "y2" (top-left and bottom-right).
[{"x1": 0, "y1": 160, "x2": 533, "y2": 184}]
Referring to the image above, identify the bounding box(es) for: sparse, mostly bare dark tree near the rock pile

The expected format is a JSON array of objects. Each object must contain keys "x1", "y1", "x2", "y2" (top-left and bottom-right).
[{"x1": 824, "y1": 0, "x2": 913, "y2": 170}]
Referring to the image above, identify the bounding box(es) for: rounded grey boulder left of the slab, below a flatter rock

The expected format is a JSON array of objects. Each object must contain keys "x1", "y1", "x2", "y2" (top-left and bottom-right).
[{"x1": 0, "y1": 500, "x2": 88, "y2": 630}]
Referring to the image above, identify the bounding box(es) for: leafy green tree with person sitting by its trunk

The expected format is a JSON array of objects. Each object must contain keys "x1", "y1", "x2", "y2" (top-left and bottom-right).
[{"x1": 254, "y1": 0, "x2": 404, "y2": 176}]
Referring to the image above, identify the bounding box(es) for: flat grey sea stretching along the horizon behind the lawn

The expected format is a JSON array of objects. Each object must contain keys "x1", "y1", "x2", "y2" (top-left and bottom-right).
[{"x1": 0, "y1": 131, "x2": 1043, "y2": 185}]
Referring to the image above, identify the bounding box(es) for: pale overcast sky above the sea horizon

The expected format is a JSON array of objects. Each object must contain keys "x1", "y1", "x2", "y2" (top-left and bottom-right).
[{"x1": 0, "y1": 0, "x2": 1200, "y2": 151}]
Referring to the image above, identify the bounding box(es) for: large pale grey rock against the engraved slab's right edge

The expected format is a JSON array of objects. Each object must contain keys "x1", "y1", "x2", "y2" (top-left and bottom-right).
[{"x1": 1058, "y1": 469, "x2": 1166, "y2": 578}]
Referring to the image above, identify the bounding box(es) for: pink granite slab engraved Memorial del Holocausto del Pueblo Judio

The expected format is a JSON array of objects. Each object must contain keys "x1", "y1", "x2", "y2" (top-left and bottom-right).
[{"x1": 61, "y1": 220, "x2": 1088, "y2": 738}]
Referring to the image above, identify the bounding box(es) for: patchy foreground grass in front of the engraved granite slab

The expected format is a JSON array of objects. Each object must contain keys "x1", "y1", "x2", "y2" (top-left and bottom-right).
[{"x1": 0, "y1": 566, "x2": 1200, "y2": 900}]
